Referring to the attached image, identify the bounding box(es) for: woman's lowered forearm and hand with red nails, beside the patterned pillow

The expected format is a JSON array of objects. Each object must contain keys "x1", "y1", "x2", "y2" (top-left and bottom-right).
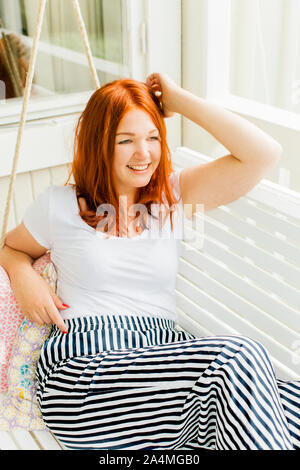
[{"x1": 11, "y1": 267, "x2": 68, "y2": 333}]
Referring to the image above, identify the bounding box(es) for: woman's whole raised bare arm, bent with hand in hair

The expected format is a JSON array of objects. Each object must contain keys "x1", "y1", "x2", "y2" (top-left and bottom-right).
[{"x1": 146, "y1": 73, "x2": 282, "y2": 218}]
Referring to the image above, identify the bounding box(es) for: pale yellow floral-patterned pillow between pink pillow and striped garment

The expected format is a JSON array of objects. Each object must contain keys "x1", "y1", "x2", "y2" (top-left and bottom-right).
[{"x1": 0, "y1": 255, "x2": 57, "y2": 431}]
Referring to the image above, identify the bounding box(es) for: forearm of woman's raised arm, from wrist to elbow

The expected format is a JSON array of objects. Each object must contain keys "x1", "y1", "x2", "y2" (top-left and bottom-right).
[{"x1": 172, "y1": 88, "x2": 282, "y2": 162}]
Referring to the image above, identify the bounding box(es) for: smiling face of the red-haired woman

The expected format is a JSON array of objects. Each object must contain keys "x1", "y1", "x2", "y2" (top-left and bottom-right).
[{"x1": 113, "y1": 109, "x2": 161, "y2": 207}]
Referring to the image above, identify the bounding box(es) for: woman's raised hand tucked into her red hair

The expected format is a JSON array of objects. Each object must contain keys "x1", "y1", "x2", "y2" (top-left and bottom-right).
[{"x1": 146, "y1": 73, "x2": 181, "y2": 117}]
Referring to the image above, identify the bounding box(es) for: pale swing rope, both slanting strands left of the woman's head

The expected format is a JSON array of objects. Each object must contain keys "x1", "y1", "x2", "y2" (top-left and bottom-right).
[{"x1": 0, "y1": 0, "x2": 100, "y2": 249}]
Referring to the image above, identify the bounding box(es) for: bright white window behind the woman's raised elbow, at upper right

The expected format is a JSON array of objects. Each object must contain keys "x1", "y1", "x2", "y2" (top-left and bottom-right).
[{"x1": 183, "y1": 0, "x2": 300, "y2": 191}]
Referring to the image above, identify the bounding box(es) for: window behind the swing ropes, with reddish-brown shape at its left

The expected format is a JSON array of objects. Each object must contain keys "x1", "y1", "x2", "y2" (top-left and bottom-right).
[{"x1": 0, "y1": 0, "x2": 131, "y2": 124}]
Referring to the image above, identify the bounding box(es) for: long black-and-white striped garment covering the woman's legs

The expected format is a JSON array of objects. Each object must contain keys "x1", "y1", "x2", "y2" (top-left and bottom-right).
[{"x1": 37, "y1": 315, "x2": 300, "y2": 450}]
